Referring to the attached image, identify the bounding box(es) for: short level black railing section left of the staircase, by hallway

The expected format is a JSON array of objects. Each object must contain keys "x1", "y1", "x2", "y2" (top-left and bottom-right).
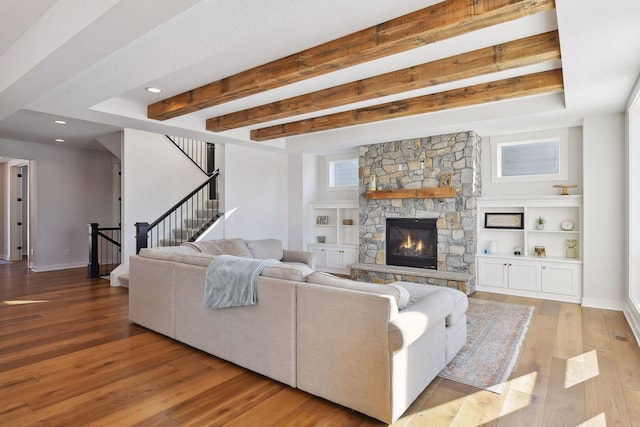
[{"x1": 87, "y1": 222, "x2": 121, "y2": 277}]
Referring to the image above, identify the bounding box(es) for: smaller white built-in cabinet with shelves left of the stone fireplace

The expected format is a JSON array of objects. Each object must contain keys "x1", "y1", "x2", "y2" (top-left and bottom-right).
[{"x1": 307, "y1": 201, "x2": 360, "y2": 274}]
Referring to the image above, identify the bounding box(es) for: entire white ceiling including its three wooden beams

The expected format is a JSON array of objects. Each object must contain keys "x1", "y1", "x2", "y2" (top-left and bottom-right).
[{"x1": 0, "y1": 0, "x2": 640, "y2": 156}]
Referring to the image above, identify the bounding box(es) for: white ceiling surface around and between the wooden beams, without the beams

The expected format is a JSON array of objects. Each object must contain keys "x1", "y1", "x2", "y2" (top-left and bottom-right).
[{"x1": 0, "y1": 0, "x2": 640, "y2": 154}]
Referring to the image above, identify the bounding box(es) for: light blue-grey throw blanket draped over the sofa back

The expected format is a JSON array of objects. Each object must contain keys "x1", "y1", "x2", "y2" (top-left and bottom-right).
[{"x1": 204, "y1": 255, "x2": 280, "y2": 308}]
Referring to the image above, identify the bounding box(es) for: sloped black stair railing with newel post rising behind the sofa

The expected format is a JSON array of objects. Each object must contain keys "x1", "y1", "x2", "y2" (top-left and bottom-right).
[{"x1": 136, "y1": 170, "x2": 220, "y2": 253}]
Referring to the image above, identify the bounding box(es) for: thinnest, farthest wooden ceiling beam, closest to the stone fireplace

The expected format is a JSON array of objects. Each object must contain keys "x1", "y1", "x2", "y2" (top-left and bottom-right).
[{"x1": 251, "y1": 69, "x2": 563, "y2": 141}]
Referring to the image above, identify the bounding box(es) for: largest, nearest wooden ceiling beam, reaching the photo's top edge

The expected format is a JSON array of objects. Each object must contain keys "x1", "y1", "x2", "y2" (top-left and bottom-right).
[{"x1": 147, "y1": 0, "x2": 555, "y2": 120}]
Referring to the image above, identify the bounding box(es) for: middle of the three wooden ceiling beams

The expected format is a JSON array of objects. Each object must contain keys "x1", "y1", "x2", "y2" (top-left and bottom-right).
[{"x1": 206, "y1": 31, "x2": 560, "y2": 132}]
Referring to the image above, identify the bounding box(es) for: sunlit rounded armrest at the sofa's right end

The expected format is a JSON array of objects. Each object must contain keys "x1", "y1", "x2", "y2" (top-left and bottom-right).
[{"x1": 389, "y1": 291, "x2": 453, "y2": 352}]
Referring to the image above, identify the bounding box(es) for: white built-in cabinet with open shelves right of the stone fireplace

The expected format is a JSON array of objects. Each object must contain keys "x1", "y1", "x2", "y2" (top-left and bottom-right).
[{"x1": 476, "y1": 196, "x2": 582, "y2": 303}]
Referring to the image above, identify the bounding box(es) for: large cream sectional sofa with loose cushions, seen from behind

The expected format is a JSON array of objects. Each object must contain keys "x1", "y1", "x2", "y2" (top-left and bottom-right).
[{"x1": 129, "y1": 239, "x2": 467, "y2": 423}]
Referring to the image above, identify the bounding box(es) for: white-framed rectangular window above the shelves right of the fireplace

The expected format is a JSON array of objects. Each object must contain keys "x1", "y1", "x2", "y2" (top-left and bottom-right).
[{"x1": 491, "y1": 130, "x2": 568, "y2": 182}]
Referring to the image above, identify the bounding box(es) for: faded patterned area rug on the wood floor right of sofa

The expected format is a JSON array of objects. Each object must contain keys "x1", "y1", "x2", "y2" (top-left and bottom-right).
[{"x1": 439, "y1": 298, "x2": 533, "y2": 394}]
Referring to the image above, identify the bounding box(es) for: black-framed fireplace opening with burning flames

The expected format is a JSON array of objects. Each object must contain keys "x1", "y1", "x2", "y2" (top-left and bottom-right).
[{"x1": 386, "y1": 218, "x2": 438, "y2": 269}]
